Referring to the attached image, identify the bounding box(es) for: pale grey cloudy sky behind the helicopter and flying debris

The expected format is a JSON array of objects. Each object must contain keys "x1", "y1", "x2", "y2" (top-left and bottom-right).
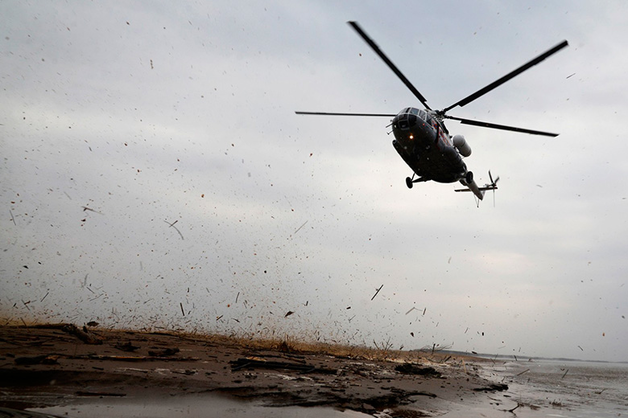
[{"x1": 0, "y1": 0, "x2": 628, "y2": 361}]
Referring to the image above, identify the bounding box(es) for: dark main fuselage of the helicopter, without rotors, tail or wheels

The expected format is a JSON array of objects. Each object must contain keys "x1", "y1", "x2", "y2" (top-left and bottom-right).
[{"x1": 392, "y1": 107, "x2": 471, "y2": 183}]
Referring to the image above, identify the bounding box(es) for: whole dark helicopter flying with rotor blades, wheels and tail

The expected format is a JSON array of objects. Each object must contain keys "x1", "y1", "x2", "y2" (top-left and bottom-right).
[{"x1": 295, "y1": 21, "x2": 569, "y2": 200}]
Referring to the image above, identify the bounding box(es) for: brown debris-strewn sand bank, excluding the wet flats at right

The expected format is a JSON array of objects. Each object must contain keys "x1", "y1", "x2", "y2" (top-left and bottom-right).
[{"x1": 0, "y1": 324, "x2": 517, "y2": 417}]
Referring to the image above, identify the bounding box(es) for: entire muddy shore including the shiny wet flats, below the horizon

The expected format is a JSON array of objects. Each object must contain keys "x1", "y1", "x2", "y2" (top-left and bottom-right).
[{"x1": 8, "y1": 324, "x2": 628, "y2": 418}]
